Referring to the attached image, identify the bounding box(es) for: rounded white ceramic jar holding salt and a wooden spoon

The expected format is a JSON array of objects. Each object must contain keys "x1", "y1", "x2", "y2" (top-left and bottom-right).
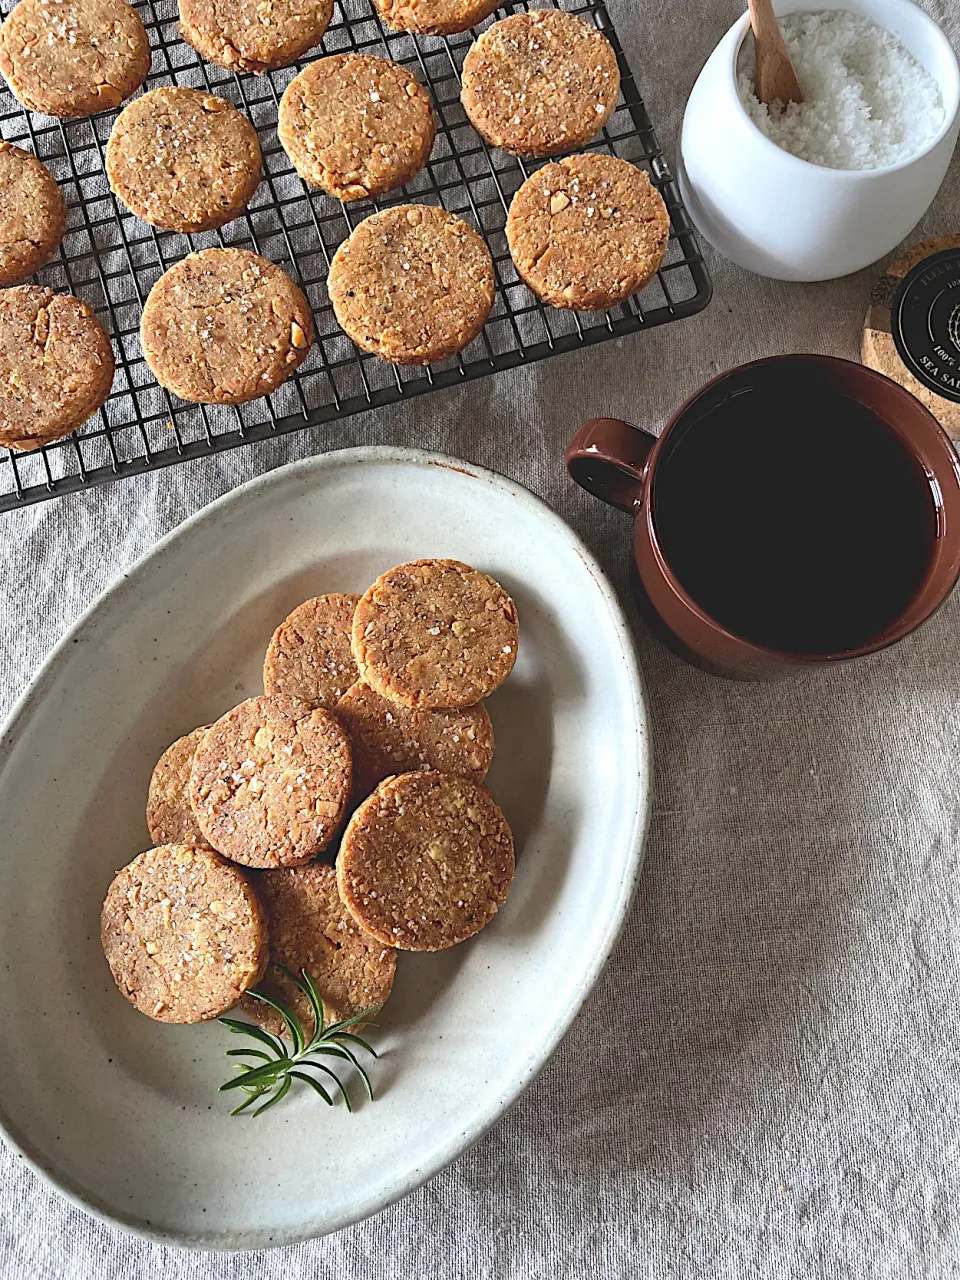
[{"x1": 678, "y1": 0, "x2": 960, "y2": 280}]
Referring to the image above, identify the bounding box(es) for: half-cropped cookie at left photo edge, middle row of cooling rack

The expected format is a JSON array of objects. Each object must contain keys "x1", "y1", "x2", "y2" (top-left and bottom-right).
[{"x1": 0, "y1": 142, "x2": 67, "y2": 287}]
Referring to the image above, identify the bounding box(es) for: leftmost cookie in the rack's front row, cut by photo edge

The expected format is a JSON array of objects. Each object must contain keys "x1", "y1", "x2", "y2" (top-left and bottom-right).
[{"x1": 0, "y1": 284, "x2": 114, "y2": 449}]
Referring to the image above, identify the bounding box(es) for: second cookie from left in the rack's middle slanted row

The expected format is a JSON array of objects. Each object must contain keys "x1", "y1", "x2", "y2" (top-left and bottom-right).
[{"x1": 106, "y1": 86, "x2": 260, "y2": 234}]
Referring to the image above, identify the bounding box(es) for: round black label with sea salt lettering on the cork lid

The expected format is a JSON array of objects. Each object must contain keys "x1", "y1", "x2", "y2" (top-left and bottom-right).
[{"x1": 890, "y1": 248, "x2": 960, "y2": 403}]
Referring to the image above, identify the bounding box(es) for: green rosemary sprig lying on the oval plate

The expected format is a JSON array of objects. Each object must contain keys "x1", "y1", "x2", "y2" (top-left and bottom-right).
[{"x1": 219, "y1": 966, "x2": 379, "y2": 1116}]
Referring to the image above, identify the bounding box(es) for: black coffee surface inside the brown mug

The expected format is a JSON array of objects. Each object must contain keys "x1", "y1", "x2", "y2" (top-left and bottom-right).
[{"x1": 652, "y1": 379, "x2": 938, "y2": 654}]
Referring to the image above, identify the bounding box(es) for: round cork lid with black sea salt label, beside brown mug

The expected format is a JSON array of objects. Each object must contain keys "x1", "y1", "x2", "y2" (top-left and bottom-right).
[{"x1": 860, "y1": 234, "x2": 960, "y2": 440}]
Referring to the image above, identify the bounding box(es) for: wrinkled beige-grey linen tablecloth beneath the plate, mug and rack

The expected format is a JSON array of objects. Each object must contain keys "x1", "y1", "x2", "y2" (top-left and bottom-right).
[{"x1": 0, "y1": 0, "x2": 960, "y2": 1280}]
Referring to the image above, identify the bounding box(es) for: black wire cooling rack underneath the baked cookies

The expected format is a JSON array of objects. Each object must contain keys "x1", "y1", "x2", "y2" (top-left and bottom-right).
[{"x1": 0, "y1": 0, "x2": 710, "y2": 511}]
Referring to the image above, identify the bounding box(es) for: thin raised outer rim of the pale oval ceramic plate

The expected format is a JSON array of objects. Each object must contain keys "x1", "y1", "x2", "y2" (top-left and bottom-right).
[{"x1": 0, "y1": 445, "x2": 653, "y2": 1252}]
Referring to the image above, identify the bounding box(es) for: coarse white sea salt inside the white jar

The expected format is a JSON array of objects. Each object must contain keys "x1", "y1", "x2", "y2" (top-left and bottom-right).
[{"x1": 737, "y1": 9, "x2": 945, "y2": 169}]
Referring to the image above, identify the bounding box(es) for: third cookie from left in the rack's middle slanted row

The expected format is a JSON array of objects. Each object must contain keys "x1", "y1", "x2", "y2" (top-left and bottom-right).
[{"x1": 276, "y1": 54, "x2": 436, "y2": 200}]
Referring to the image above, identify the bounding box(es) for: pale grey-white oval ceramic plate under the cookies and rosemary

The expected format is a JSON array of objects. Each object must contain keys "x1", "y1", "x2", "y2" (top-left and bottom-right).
[{"x1": 0, "y1": 448, "x2": 649, "y2": 1249}]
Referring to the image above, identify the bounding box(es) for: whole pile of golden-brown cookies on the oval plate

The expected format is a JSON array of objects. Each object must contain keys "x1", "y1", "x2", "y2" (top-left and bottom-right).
[{"x1": 101, "y1": 559, "x2": 518, "y2": 1034}]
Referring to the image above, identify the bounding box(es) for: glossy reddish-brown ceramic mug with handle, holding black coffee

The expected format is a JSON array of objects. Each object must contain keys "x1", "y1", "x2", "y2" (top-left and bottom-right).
[{"x1": 567, "y1": 356, "x2": 960, "y2": 680}]
